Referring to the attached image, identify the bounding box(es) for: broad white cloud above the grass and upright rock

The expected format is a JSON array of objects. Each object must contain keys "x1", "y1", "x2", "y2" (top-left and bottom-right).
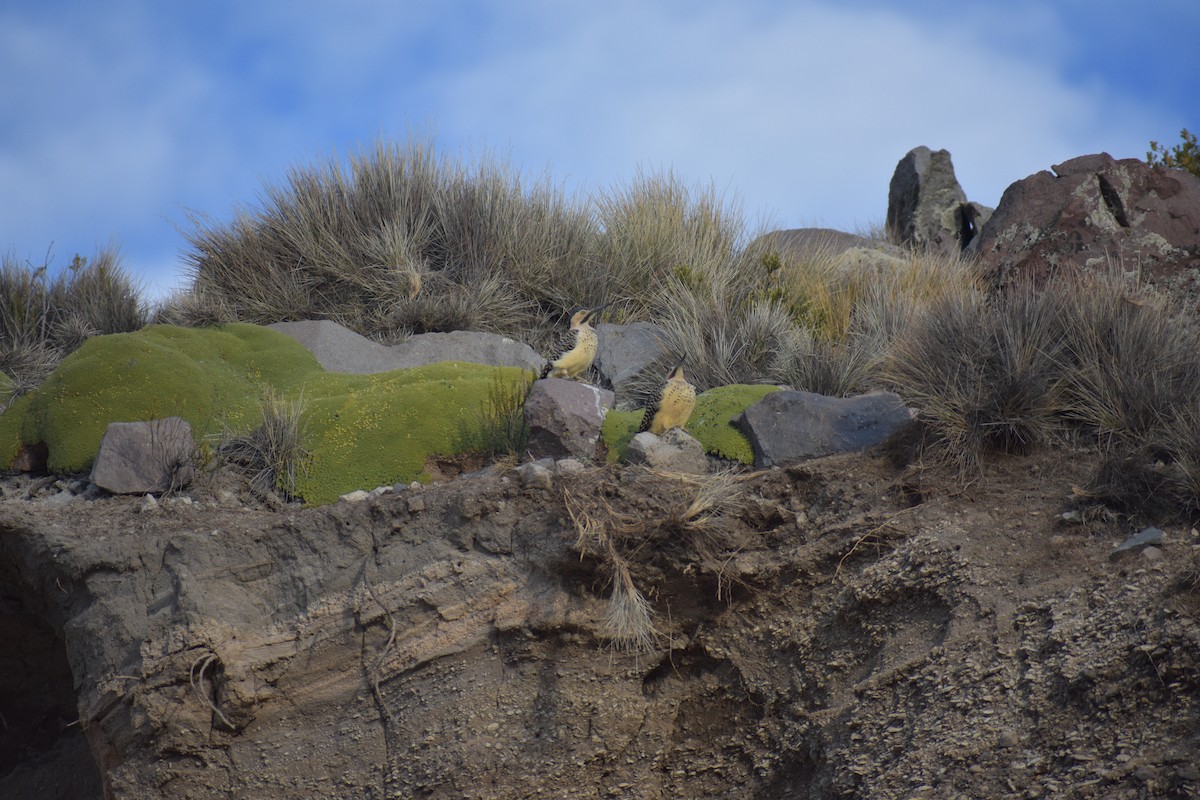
[{"x1": 420, "y1": 4, "x2": 1171, "y2": 227}]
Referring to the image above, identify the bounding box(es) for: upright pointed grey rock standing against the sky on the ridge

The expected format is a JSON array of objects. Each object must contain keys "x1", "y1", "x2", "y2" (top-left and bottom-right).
[{"x1": 887, "y1": 146, "x2": 991, "y2": 254}]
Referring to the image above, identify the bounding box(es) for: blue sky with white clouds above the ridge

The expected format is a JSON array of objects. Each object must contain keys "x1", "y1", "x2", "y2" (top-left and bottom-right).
[{"x1": 0, "y1": 0, "x2": 1200, "y2": 296}]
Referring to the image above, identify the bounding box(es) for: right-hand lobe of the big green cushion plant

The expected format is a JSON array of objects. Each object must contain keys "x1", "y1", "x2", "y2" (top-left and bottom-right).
[{"x1": 296, "y1": 361, "x2": 528, "y2": 504}]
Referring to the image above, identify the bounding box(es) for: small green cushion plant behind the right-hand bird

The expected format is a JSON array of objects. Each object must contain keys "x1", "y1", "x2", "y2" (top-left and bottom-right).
[{"x1": 602, "y1": 384, "x2": 779, "y2": 464}]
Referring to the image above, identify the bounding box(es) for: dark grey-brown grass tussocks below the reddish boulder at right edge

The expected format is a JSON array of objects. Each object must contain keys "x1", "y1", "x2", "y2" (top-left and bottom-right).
[{"x1": 882, "y1": 263, "x2": 1200, "y2": 521}]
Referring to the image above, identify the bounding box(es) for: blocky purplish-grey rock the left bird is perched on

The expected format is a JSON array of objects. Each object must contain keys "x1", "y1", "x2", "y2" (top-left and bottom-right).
[{"x1": 524, "y1": 378, "x2": 613, "y2": 461}]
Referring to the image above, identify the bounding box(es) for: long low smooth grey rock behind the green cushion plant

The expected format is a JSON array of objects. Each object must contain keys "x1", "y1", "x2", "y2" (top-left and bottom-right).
[{"x1": 269, "y1": 319, "x2": 546, "y2": 374}]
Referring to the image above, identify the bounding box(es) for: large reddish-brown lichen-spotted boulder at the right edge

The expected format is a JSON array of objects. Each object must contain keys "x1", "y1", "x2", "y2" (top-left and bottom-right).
[{"x1": 968, "y1": 154, "x2": 1200, "y2": 288}]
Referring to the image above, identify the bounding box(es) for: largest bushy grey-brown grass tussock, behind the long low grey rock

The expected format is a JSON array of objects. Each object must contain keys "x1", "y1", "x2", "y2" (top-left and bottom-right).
[{"x1": 162, "y1": 138, "x2": 595, "y2": 339}]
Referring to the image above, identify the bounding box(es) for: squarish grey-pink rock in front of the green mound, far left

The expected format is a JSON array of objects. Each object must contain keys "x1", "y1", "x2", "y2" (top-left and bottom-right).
[{"x1": 91, "y1": 416, "x2": 196, "y2": 494}]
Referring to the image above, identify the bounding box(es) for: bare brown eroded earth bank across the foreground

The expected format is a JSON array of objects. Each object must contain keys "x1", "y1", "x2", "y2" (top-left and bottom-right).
[{"x1": 0, "y1": 450, "x2": 1200, "y2": 800}]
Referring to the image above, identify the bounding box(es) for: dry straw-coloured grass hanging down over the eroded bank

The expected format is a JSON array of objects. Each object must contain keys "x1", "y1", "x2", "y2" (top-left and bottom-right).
[{"x1": 563, "y1": 469, "x2": 749, "y2": 652}]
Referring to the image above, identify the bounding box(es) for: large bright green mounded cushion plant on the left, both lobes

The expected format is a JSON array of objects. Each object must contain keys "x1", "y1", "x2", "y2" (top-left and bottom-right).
[{"x1": 0, "y1": 324, "x2": 529, "y2": 504}]
